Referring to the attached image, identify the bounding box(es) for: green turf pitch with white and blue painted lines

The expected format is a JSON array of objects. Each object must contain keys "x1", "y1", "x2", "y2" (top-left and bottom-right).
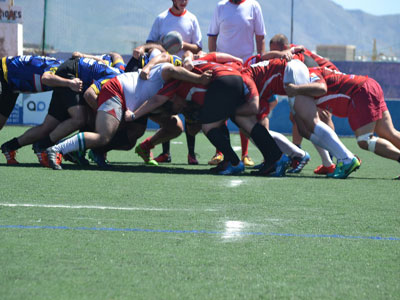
[{"x1": 0, "y1": 126, "x2": 400, "y2": 299}]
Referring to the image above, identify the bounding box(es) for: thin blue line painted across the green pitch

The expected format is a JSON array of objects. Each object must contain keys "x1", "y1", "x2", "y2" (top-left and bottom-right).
[{"x1": 0, "y1": 225, "x2": 400, "y2": 241}]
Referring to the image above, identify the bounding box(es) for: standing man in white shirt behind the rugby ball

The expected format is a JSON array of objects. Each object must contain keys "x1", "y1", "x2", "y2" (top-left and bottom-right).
[{"x1": 146, "y1": 0, "x2": 202, "y2": 164}]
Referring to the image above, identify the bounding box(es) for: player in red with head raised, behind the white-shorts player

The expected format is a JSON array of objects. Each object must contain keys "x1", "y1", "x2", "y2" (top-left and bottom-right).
[{"x1": 268, "y1": 34, "x2": 339, "y2": 174}]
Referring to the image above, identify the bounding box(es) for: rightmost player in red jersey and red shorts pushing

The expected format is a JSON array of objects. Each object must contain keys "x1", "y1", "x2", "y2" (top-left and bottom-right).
[{"x1": 289, "y1": 68, "x2": 400, "y2": 176}]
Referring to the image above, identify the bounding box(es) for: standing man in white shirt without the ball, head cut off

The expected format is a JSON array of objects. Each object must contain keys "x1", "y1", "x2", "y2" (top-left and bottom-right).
[{"x1": 207, "y1": 0, "x2": 266, "y2": 166}]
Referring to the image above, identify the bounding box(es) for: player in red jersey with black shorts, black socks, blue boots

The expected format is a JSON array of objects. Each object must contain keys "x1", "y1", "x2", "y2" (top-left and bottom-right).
[{"x1": 125, "y1": 60, "x2": 287, "y2": 176}]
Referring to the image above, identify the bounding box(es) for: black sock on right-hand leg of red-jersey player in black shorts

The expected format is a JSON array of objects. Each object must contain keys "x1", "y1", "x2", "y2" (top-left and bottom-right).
[{"x1": 250, "y1": 123, "x2": 282, "y2": 164}]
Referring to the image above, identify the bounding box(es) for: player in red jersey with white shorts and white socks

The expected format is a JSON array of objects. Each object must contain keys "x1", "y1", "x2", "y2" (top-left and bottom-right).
[{"x1": 242, "y1": 59, "x2": 360, "y2": 178}]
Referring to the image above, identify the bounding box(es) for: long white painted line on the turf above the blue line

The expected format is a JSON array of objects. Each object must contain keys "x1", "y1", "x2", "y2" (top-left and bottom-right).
[{"x1": 0, "y1": 203, "x2": 217, "y2": 211}]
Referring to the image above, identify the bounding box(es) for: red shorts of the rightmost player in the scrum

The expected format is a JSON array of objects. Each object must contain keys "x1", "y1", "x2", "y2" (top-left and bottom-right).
[{"x1": 347, "y1": 78, "x2": 388, "y2": 131}]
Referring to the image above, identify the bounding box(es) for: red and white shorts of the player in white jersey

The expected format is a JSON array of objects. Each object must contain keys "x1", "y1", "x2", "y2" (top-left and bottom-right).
[{"x1": 97, "y1": 77, "x2": 126, "y2": 121}]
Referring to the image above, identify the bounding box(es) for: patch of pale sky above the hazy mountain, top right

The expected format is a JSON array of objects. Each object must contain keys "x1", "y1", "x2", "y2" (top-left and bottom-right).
[{"x1": 332, "y1": 0, "x2": 400, "y2": 16}]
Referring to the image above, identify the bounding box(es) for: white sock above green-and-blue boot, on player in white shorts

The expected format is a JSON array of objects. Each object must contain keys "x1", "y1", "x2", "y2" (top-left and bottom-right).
[{"x1": 310, "y1": 121, "x2": 354, "y2": 163}]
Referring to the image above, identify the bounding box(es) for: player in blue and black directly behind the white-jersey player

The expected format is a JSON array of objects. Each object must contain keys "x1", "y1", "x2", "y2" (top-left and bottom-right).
[{"x1": 2, "y1": 58, "x2": 121, "y2": 166}]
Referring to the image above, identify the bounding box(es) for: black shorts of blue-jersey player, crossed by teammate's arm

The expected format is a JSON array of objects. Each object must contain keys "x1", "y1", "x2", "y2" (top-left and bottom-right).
[{"x1": 48, "y1": 59, "x2": 86, "y2": 122}]
